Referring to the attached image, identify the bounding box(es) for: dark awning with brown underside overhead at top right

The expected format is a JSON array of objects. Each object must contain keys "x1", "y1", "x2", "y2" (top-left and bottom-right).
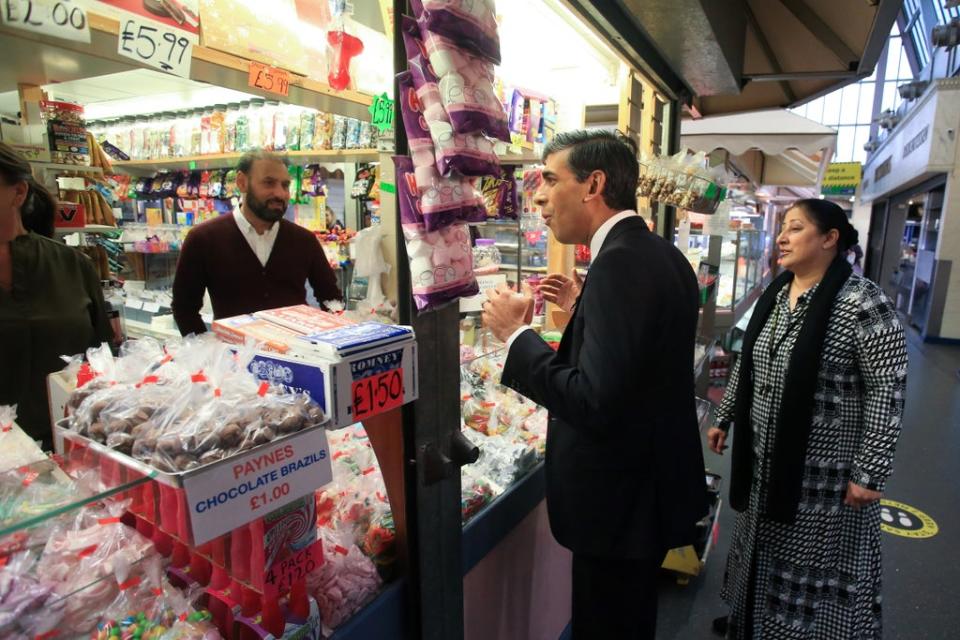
[{"x1": 568, "y1": 0, "x2": 902, "y2": 116}]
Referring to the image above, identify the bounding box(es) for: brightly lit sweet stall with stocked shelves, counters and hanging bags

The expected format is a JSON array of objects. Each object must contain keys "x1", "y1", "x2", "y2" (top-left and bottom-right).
[{"x1": 0, "y1": 0, "x2": 736, "y2": 638}]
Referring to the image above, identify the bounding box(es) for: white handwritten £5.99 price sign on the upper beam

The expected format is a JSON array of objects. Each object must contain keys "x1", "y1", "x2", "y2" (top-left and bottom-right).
[{"x1": 117, "y1": 18, "x2": 193, "y2": 78}]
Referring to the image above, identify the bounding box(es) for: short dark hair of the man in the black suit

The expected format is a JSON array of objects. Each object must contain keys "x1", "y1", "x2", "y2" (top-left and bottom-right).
[{"x1": 543, "y1": 129, "x2": 640, "y2": 211}]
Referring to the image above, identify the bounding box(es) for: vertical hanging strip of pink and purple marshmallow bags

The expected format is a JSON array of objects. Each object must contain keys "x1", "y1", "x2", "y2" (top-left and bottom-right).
[{"x1": 394, "y1": 0, "x2": 516, "y2": 310}]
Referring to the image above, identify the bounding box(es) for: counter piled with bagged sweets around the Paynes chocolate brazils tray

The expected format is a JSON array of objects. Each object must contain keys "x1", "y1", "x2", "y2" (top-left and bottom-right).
[{"x1": 0, "y1": 339, "x2": 404, "y2": 640}]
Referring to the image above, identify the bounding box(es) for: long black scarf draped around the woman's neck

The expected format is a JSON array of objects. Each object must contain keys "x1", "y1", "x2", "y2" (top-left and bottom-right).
[{"x1": 730, "y1": 257, "x2": 852, "y2": 524}]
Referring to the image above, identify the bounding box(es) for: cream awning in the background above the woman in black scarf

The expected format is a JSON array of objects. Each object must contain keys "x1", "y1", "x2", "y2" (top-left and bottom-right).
[{"x1": 680, "y1": 109, "x2": 837, "y2": 187}]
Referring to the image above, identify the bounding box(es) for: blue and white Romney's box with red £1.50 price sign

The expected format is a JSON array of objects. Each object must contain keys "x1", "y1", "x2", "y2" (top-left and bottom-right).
[{"x1": 250, "y1": 338, "x2": 420, "y2": 427}]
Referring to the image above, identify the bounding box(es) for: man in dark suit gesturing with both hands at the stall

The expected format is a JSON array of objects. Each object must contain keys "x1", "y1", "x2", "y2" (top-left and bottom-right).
[{"x1": 483, "y1": 131, "x2": 708, "y2": 640}]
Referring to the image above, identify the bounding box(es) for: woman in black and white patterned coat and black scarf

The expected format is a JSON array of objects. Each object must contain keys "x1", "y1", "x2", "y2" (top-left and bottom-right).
[{"x1": 707, "y1": 200, "x2": 907, "y2": 640}]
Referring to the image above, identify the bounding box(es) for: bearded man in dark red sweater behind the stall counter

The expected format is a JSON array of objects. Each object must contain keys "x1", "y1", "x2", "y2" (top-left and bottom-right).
[{"x1": 173, "y1": 151, "x2": 341, "y2": 335}]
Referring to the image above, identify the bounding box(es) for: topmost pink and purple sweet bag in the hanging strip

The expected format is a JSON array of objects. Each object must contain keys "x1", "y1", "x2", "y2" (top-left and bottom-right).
[{"x1": 410, "y1": 0, "x2": 500, "y2": 64}]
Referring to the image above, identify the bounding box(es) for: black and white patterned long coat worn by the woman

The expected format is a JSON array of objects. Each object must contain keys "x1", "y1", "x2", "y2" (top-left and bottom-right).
[{"x1": 717, "y1": 275, "x2": 907, "y2": 640}]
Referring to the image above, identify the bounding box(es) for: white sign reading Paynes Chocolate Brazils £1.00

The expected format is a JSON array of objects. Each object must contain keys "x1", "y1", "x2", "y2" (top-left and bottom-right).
[{"x1": 184, "y1": 428, "x2": 333, "y2": 544}]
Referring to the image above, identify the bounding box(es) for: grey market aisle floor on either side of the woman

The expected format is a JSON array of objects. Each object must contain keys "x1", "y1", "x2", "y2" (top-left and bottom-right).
[{"x1": 657, "y1": 332, "x2": 960, "y2": 640}]
